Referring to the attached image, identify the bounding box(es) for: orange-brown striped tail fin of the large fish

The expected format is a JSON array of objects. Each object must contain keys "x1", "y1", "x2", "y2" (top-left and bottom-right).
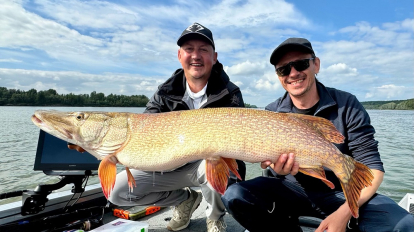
[{"x1": 338, "y1": 156, "x2": 374, "y2": 218}]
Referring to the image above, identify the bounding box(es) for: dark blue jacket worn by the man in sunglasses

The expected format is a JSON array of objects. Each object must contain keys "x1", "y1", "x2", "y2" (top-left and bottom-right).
[{"x1": 266, "y1": 81, "x2": 384, "y2": 189}]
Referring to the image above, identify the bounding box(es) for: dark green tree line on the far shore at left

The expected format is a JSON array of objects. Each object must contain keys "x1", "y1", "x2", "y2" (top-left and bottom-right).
[{"x1": 0, "y1": 87, "x2": 149, "y2": 107}]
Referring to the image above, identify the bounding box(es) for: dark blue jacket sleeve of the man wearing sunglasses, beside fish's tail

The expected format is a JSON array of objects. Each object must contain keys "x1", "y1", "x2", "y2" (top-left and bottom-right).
[{"x1": 346, "y1": 96, "x2": 384, "y2": 172}]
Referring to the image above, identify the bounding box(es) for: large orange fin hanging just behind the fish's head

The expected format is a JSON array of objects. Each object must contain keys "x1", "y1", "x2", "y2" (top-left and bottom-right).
[{"x1": 98, "y1": 155, "x2": 116, "y2": 199}]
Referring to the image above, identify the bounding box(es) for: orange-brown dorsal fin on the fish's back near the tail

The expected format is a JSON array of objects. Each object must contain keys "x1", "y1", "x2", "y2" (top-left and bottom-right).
[{"x1": 288, "y1": 113, "x2": 345, "y2": 144}]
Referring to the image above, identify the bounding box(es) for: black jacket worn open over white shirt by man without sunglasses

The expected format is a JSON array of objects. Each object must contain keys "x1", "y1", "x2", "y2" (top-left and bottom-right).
[{"x1": 144, "y1": 61, "x2": 246, "y2": 182}]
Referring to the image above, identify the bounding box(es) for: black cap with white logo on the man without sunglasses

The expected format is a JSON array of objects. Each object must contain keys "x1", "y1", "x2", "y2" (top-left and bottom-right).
[{"x1": 177, "y1": 23, "x2": 216, "y2": 49}]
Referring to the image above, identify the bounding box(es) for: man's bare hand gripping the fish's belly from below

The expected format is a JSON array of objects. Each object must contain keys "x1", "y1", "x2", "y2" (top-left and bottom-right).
[{"x1": 260, "y1": 153, "x2": 299, "y2": 175}]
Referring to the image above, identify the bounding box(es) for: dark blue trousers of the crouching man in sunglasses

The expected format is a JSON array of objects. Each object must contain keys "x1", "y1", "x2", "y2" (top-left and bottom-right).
[{"x1": 222, "y1": 177, "x2": 414, "y2": 232}]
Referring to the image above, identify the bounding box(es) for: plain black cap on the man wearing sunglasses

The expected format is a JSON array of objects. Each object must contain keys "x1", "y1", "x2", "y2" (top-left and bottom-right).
[{"x1": 270, "y1": 38, "x2": 315, "y2": 65}]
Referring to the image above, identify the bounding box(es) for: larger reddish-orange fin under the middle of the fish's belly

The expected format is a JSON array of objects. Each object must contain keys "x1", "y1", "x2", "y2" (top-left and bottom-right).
[{"x1": 206, "y1": 157, "x2": 231, "y2": 195}]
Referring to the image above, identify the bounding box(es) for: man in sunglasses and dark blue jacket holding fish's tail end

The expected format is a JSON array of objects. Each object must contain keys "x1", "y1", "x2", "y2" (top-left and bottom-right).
[{"x1": 222, "y1": 38, "x2": 414, "y2": 232}]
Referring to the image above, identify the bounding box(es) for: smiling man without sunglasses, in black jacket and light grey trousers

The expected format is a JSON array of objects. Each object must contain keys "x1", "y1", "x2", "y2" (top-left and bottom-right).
[{"x1": 109, "y1": 23, "x2": 246, "y2": 232}]
